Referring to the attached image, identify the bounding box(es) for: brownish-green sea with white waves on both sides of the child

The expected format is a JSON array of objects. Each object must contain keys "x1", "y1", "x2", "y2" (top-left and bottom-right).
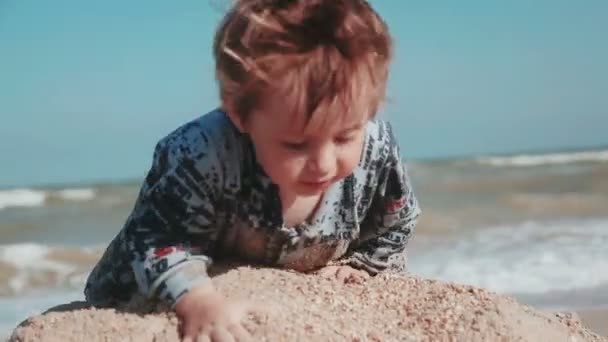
[{"x1": 0, "y1": 149, "x2": 608, "y2": 340}]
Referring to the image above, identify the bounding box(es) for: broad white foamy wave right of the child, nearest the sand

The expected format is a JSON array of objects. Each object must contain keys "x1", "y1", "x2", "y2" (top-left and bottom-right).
[{"x1": 410, "y1": 219, "x2": 608, "y2": 294}]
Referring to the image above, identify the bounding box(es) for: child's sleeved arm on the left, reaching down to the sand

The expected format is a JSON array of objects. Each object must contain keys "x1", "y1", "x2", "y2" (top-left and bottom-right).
[{"x1": 123, "y1": 135, "x2": 223, "y2": 305}]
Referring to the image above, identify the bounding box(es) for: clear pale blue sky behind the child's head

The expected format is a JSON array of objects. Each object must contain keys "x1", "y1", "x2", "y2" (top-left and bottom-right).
[{"x1": 0, "y1": 0, "x2": 608, "y2": 187}]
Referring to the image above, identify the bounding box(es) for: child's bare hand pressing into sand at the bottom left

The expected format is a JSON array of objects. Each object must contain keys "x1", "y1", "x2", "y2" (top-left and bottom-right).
[{"x1": 175, "y1": 282, "x2": 251, "y2": 342}]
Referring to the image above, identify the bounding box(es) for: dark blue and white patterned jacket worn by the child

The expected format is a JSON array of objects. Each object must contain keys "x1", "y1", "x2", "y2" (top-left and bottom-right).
[{"x1": 85, "y1": 110, "x2": 420, "y2": 306}]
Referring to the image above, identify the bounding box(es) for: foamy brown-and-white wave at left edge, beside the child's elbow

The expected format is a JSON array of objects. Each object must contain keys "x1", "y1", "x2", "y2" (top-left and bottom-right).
[{"x1": 0, "y1": 243, "x2": 101, "y2": 296}]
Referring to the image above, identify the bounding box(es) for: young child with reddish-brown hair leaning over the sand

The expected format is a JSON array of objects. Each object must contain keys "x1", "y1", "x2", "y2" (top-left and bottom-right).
[{"x1": 85, "y1": 0, "x2": 419, "y2": 339}]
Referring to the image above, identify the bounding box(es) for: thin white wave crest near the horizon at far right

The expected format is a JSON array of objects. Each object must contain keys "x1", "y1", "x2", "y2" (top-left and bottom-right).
[{"x1": 477, "y1": 150, "x2": 608, "y2": 166}]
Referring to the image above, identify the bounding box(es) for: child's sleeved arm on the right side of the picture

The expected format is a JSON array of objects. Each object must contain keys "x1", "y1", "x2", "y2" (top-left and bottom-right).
[{"x1": 345, "y1": 124, "x2": 420, "y2": 274}]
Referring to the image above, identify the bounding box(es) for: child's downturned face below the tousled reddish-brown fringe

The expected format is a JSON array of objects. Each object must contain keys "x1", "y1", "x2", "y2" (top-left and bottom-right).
[{"x1": 233, "y1": 96, "x2": 369, "y2": 196}]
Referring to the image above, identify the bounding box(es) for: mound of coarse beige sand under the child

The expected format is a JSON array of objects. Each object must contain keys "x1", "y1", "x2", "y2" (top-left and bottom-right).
[{"x1": 9, "y1": 267, "x2": 608, "y2": 342}]
